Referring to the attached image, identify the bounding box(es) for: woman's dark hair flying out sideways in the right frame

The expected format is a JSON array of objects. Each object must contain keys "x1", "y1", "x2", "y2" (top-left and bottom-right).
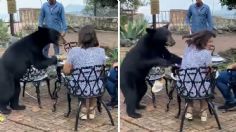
[{"x1": 182, "y1": 30, "x2": 216, "y2": 50}]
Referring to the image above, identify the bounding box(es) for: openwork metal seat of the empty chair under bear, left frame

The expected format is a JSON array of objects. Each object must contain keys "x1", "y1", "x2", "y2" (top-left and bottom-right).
[{"x1": 20, "y1": 65, "x2": 47, "y2": 82}]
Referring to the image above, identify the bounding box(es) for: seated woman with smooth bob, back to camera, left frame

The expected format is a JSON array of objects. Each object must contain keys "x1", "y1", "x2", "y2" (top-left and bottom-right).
[{"x1": 63, "y1": 25, "x2": 105, "y2": 119}]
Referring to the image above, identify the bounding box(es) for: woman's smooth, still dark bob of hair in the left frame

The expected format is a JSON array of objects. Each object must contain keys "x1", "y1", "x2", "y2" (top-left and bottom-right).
[{"x1": 79, "y1": 25, "x2": 99, "y2": 49}]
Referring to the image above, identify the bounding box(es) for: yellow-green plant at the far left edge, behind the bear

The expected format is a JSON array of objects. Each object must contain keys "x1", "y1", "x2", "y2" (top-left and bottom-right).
[{"x1": 0, "y1": 19, "x2": 10, "y2": 42}]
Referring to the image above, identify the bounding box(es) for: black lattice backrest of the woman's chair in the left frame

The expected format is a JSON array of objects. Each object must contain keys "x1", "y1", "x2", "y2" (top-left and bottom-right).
[{"x1": 65, "y1": 65, "x2": 106, "y2": 98}]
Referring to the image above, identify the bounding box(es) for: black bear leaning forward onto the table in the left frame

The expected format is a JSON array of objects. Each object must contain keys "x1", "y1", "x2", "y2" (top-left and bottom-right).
[{"x1": 0, "y1": 27, "x2": 60, "y2": 114}]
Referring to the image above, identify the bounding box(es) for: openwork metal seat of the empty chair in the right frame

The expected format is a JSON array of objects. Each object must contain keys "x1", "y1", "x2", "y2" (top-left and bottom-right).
[{"x1": 146, "y1": 67, "x2": 165, "y2": 81}]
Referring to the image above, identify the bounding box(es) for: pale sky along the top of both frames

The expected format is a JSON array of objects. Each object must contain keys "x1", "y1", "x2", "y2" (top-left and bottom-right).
[{"x1": 0, "y1": 0, "x2": 236, "y2": 18}]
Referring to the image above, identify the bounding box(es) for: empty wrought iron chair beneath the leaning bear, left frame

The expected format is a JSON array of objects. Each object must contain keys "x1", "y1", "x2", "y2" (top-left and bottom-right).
[{"x1": 20, "y1": 66, "x2": 52, "y2": 108}]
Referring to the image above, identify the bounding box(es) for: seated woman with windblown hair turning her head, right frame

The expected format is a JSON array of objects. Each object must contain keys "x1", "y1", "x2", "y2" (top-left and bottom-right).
[{"x1": 181, "y1": 30, "x2": 216, "y2": 121}]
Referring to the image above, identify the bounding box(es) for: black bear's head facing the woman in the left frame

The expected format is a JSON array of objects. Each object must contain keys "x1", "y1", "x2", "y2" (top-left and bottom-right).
[{"x1": 37, "y1": 27, "x2": 61, "y2": 46}]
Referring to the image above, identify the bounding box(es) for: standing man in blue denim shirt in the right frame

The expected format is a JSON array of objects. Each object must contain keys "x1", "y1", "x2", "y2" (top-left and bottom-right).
[{"x1": 186, "y1": 0, "x2": 213, "y2": 34}]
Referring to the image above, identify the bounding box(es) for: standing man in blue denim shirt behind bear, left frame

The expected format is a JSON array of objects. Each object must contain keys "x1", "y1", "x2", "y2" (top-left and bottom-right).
[{"x1": 39, "y1": 0, "x2": 67, "y2": 56}]
